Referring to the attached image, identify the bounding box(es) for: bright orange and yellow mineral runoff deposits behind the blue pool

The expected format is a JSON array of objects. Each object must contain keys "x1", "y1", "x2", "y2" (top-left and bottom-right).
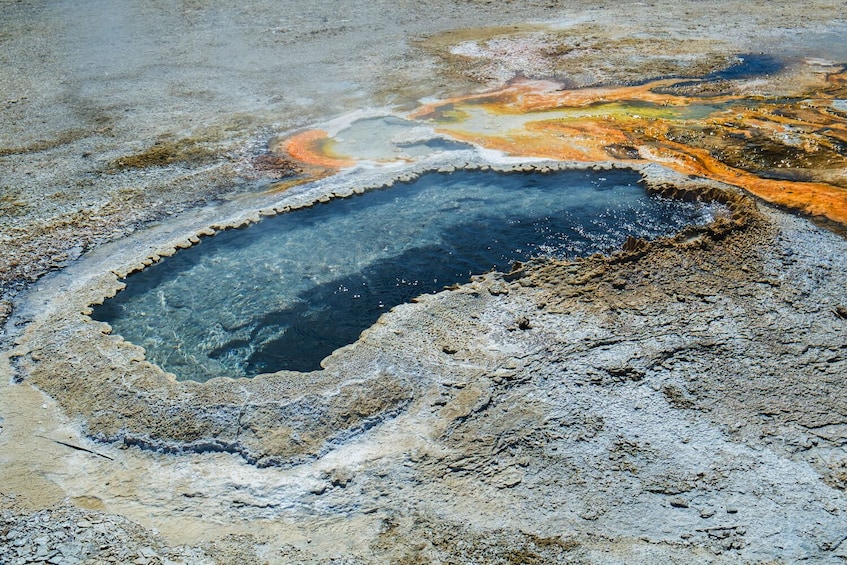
[{"x1": 283, "y1": 66, "x2": 847, "y2": 225}]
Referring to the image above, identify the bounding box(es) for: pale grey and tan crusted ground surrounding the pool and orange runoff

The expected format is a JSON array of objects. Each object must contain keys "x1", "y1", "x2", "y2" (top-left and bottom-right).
[{"x1": 0, "y1": 1, "x2": 847, "y2": 564}]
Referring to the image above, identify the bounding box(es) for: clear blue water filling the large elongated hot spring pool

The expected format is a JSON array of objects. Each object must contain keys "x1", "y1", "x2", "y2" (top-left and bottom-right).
[{"x1": 93, "y1": 167, "x2": 715, "y2": 381}]
